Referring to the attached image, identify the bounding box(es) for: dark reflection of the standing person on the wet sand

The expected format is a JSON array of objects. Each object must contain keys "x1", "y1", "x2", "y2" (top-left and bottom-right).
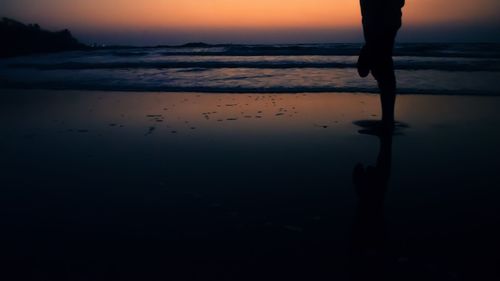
[{"x1": 351, "y1": 133, "x2": 392, "y2": 280}]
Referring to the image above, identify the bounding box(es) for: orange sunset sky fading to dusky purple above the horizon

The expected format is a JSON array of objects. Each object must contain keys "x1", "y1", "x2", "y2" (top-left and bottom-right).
[{"x1": 0, "y1": 0, "x2": 500, "y2": 45}]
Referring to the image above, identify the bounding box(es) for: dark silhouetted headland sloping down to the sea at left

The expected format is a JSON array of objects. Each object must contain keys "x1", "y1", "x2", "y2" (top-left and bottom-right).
[{"x1": 0, "y1": 18, "x2": 88, "y2": 57}]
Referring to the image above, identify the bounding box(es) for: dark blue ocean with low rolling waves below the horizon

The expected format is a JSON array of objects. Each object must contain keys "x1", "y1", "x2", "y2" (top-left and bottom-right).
[{"x1": 0, "y1": 44, "x2": 500, "y2": 96}]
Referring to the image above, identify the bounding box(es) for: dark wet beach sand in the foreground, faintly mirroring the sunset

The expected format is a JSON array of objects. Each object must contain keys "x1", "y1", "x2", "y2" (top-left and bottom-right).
[{"x1": 0, "y1": 89, "x2": 500, "y2": 280}]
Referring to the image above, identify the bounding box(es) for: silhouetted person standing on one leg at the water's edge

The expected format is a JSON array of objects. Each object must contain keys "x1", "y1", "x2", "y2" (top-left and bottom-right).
[{"x1": 358, "y1": 0, "x2": 405, "y2": 128}]
